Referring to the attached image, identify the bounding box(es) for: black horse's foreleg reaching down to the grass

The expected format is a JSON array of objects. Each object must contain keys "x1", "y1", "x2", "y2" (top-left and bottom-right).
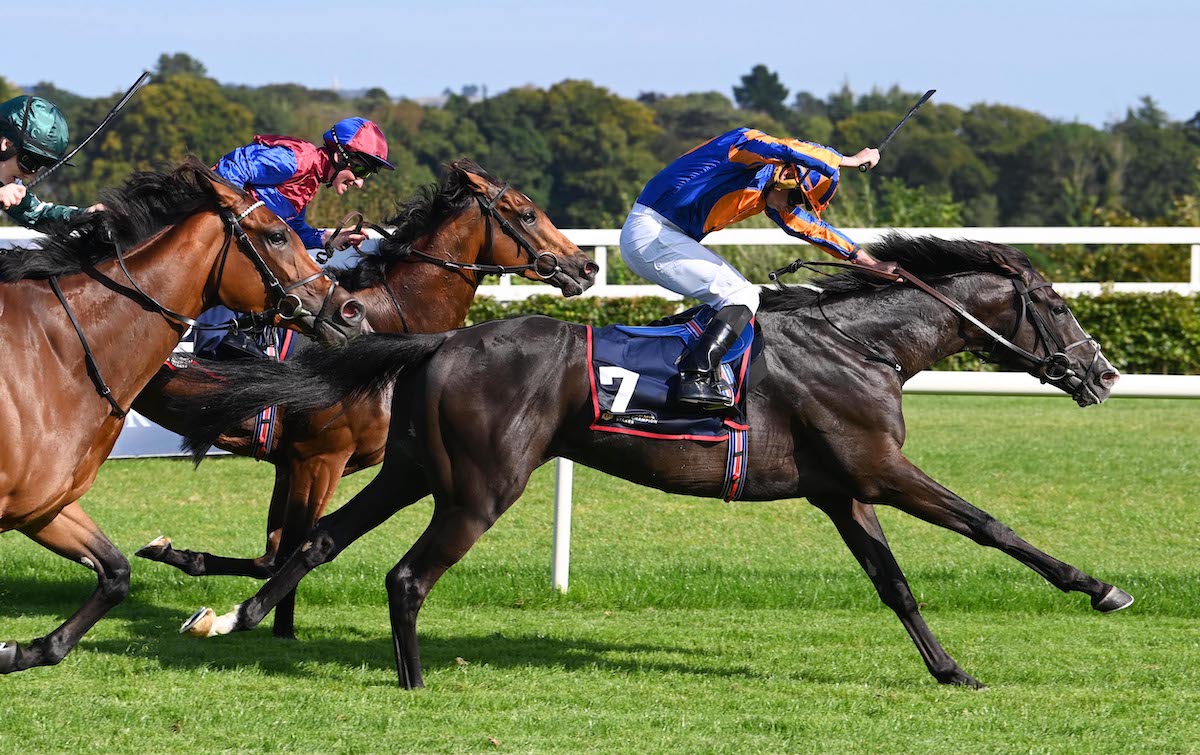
[{"x1": 810, "y1": 498, "x2": 982, "y2": 688}]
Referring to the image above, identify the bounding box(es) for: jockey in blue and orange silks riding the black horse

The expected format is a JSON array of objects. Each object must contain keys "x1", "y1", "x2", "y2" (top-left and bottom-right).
[{"x1": 620, "y1": 128, "x2": 895, "y2": 409}]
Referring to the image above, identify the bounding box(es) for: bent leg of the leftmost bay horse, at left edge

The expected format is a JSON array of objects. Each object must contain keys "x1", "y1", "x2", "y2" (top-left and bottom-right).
[{"x1": 0, "y1": 503, "x2": 130, "y2": 673}]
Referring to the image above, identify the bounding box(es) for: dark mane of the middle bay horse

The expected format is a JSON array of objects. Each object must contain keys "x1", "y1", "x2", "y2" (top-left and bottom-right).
[{"x1": 329, "y1": 160, "x2": 500, "y2": 292}]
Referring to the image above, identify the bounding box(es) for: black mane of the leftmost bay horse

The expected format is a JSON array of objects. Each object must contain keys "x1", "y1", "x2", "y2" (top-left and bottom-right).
[{"x1": 0, "y1": 157, "x2": 240, "y2": 281}]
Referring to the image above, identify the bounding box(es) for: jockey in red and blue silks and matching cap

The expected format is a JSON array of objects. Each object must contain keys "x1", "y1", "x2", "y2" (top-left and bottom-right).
[{"x1": 193, "y1": 118, "x2": 395, "y2": 356}]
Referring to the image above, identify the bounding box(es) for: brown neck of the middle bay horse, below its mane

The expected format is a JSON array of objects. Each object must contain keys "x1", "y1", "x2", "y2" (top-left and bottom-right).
[{"x1": 367, "y1": 212, "x2": 490, "y2": 332}]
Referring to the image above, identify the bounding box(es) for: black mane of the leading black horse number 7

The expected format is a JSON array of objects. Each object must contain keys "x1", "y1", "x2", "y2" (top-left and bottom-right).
[{"x1": 760, "y1": 233, "x2": 1031, "y2": 312}]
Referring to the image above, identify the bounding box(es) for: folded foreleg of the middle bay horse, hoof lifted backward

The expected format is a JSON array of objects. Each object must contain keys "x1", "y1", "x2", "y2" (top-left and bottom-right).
[{"x1": 133, "y1": 463, "x2": 292, "y2": 580}]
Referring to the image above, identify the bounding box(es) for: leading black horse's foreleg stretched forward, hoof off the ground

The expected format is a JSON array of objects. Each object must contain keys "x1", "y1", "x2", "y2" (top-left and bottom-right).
[{"x1": 859, "y1": 456, "x2": 1133, "y2": 613}]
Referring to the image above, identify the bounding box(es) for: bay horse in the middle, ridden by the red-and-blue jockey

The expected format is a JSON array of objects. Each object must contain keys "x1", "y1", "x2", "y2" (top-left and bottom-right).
[{"x1": 133, "y1": 160, "x2": 598, "y2": 637}]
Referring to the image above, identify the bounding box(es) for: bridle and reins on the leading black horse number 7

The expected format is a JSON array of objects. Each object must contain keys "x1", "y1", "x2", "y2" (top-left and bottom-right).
[{"x1": 770, "y1": 259, "x2": 1102, "y2": 400}]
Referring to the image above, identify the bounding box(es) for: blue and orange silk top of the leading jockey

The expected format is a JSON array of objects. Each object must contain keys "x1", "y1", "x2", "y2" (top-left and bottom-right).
[{"x1": 637, "y1": 127, "x2": 857, "y2": 257}]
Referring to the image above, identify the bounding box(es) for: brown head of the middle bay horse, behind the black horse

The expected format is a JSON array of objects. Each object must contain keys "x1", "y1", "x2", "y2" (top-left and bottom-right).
[{"x1": 450, "y1": 160, "x2": 600, "y2": 296}]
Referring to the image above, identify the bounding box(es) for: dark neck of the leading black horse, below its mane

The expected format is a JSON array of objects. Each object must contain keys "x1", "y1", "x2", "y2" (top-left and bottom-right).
[{"x1": 826, "y1": 274, "x2": 1010, "y2": 378}]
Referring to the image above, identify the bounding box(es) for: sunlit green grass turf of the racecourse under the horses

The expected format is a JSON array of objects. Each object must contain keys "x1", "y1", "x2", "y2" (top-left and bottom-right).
[{"x1": 0, "y1": 396, "x2": 1200, "y2": 753}]
